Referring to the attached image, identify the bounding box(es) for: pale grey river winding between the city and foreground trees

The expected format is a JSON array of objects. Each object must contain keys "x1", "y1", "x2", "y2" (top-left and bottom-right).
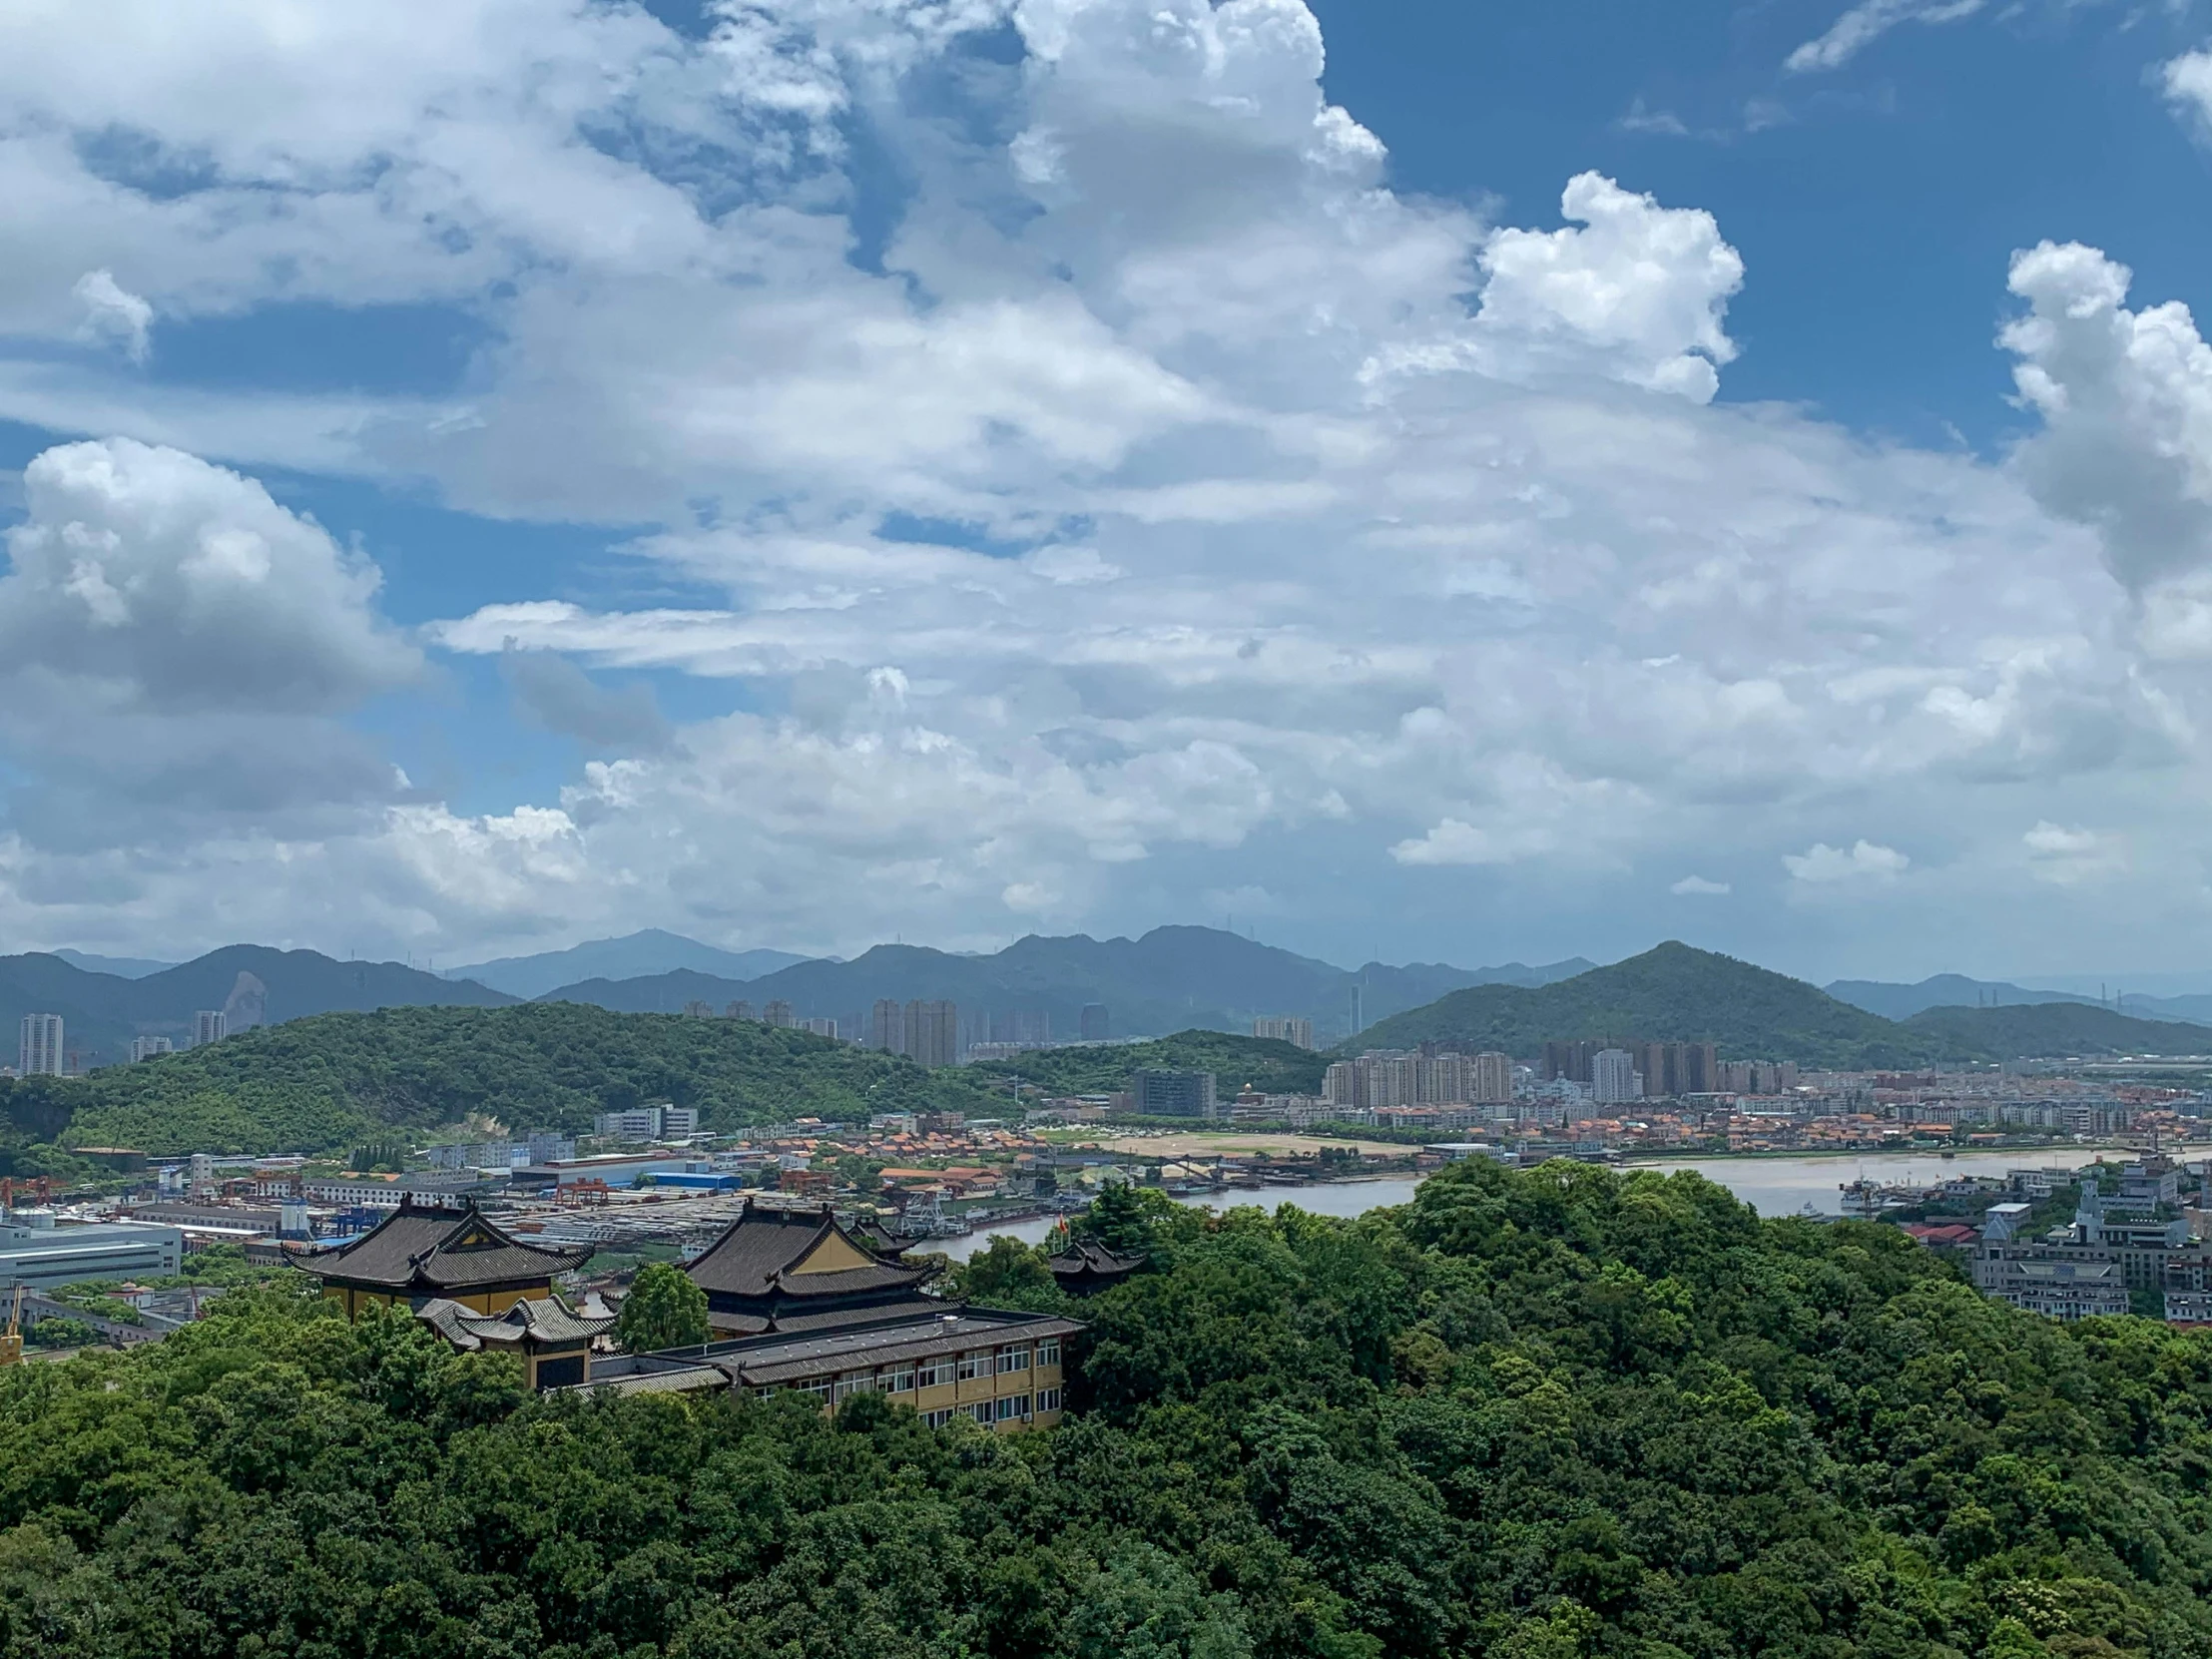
[{"x1": 924, "y1": 1146, "x2": 2099, "y2": 1261}]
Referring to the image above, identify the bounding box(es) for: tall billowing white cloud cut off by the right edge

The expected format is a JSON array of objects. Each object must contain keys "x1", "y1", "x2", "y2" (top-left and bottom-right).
[{"x1": 1999, "y1": 242, "x2": 2212, "y2": 653}]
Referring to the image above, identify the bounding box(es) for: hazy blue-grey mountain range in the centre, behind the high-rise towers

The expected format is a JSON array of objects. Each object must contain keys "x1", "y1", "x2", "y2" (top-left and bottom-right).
[{"x1": 521, "y1": 927, "x2": 1590, "y2": 1042}]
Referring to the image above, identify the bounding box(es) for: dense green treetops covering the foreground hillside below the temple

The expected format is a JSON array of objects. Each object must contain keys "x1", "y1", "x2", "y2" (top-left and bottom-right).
[{"x1": 0, "y1": 1164, "x2": 2212, "y2": 1659}]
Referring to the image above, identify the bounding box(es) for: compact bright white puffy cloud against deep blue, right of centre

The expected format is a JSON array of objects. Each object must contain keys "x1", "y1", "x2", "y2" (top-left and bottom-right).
[{"x1": 1475, "y1": 173, "x2": 1743, "y2": 402}]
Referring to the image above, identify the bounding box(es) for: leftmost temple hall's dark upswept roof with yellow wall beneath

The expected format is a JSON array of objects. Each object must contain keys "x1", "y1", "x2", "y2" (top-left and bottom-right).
[{"x1": 289, "y1": 1199, "x2": 591, "y2": 1319}]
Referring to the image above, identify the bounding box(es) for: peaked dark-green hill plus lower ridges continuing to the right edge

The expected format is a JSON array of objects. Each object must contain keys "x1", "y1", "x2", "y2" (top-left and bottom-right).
[{"x1": 1348, "y1": 940, "x2": 2212, "y2": 1071}]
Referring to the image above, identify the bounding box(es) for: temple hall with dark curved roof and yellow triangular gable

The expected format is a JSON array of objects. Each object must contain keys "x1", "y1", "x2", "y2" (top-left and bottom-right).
[{"x1": 684, "y1": 1199, "x2": 942, "y2": 1336}]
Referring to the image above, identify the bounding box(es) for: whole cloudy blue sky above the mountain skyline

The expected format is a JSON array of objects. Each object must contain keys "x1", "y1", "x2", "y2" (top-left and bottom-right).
[{"x1": 0, "y1": 0, "x2": 2212, "y2": 977}]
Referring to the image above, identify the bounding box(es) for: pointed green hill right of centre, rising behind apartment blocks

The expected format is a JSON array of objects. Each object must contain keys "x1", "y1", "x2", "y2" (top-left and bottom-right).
[{"x1": 1348, "y1": 940, "x2": 1936, "y2": 1066}]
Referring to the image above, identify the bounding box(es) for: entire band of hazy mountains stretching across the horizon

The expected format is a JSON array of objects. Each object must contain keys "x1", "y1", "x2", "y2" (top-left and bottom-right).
[{"x1": 13, "y1": 927, "x2": 2212, "y2": 1068}]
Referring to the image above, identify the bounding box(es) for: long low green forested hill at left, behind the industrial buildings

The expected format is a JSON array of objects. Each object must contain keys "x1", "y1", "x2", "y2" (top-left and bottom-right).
[{"x1": 0, "y1": 1002, "x2": 975, "y2": 1153}]
